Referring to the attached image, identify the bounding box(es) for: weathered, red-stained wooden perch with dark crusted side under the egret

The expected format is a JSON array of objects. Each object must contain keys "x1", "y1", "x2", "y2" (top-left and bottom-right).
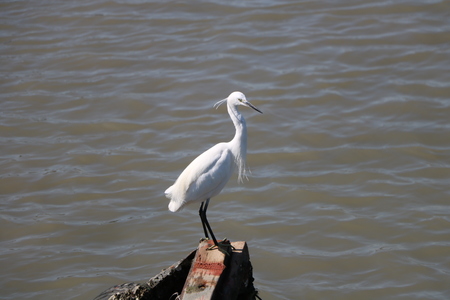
[{"x1": 95, "y1": 240, "x2": 260, "y2": 300}]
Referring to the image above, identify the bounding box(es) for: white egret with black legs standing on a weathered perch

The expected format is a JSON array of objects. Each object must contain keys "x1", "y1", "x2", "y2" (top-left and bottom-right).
[{"x1": 164, "y1": 91, "x2": 262, "y2": 252}]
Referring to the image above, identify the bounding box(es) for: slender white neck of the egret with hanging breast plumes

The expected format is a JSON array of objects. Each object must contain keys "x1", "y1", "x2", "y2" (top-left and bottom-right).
[{"x1": 227, "y1": 105, "x2": 247, "y2": 181}]
